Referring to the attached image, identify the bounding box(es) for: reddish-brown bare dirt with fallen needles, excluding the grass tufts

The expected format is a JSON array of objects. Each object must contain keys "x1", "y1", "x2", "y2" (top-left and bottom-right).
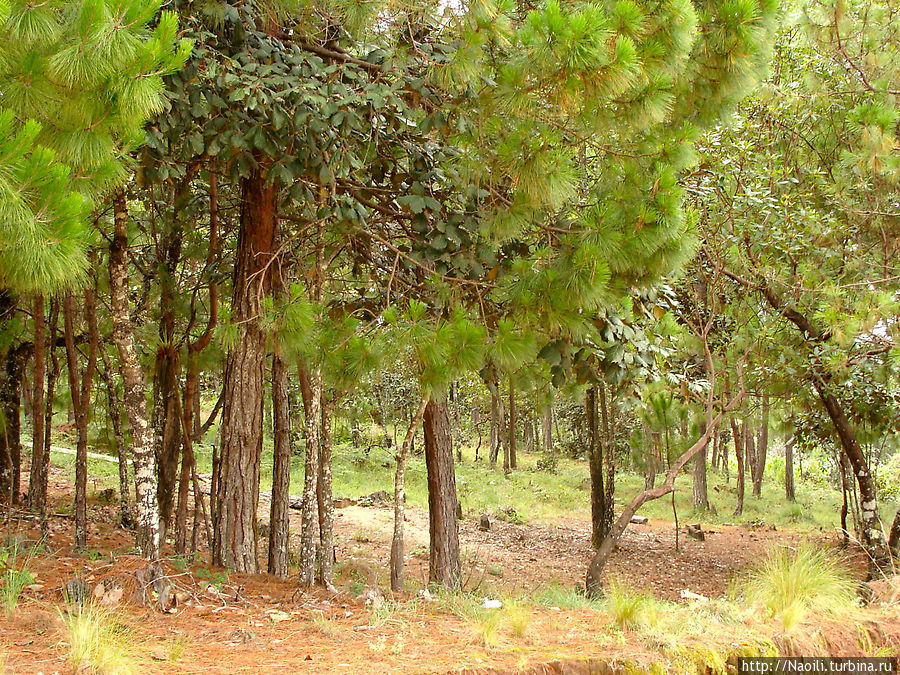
[{"x1": 0, "y1": 462, "x2": 900, "y2": 675}]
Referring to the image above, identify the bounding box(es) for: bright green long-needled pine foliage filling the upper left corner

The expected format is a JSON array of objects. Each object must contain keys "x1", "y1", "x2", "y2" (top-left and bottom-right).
[{"x1": 0, "y1": 0, "x2": 191, "y2": 557}]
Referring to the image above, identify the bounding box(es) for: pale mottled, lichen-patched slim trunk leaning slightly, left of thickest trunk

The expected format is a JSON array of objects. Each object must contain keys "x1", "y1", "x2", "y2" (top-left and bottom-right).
[{"x1": 109, "y1": 190, "x2": 160, "y2": 560}]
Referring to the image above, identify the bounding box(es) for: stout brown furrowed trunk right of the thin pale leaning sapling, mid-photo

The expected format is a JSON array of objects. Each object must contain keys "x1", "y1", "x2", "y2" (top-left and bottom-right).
[{"x1": 423, "y1": 400, "x2": 462, "y2": 588}]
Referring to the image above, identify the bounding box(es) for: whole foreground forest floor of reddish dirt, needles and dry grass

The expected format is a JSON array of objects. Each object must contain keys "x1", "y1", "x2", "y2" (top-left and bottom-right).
[{"x1": 0, "y1": 460, "x2": 900, "y2": 674}]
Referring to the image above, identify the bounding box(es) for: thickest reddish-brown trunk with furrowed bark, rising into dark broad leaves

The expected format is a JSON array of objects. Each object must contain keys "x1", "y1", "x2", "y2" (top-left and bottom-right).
[{"x1": 213, "y1": 167, "x2": 278, "y2": 572}]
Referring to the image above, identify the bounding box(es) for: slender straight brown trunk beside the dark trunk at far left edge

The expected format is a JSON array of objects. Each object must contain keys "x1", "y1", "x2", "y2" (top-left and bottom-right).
[{"x1": 28, "y1": 293, "x2": 52, "y2": 524}]
